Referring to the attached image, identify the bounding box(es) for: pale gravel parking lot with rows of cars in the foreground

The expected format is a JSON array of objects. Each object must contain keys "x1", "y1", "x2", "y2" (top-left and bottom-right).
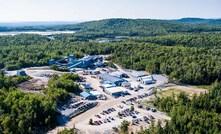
[{"x1": 76, "y1": 100, "x2": 170, "y2": 133}]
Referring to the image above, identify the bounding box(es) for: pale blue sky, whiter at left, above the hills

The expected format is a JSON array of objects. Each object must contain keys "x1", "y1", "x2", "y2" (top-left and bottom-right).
[{"x1": 0, "y1": 0, "x2": 221, "y2": 22}]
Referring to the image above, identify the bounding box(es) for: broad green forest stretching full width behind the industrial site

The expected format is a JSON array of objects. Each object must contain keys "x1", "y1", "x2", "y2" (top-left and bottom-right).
[{"x1": 0, "y1": 33, "x2": 221, "y2": 85}]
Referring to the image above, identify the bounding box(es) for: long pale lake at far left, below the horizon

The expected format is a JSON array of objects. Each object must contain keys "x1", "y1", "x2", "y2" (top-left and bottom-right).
[{"x1": 0, "y1": 31, "x2": 75, "y2": 36}]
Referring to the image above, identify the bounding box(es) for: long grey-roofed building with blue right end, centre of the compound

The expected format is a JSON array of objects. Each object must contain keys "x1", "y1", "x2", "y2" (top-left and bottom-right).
[{"x1": 97, "y1": 74, "x2": 126, "y2": 86}]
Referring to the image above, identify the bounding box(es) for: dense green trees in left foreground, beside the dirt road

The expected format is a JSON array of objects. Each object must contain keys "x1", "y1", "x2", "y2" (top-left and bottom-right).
[{"x1": 0, "y1": 73, "x2": 79, "y2": 134}]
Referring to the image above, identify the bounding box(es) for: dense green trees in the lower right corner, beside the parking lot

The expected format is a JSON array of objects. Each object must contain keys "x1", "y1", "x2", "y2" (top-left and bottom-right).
[{"x1": 138, "y1": 82, "x2": 221, "y2": 134}]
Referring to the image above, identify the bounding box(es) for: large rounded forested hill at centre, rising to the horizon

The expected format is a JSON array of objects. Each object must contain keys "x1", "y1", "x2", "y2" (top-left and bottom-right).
[{"x1": 60, "y1": 19, "x2": 221, "y2": 36}]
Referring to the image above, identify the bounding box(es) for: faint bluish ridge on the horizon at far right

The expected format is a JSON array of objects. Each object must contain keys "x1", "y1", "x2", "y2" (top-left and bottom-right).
[{"x1": 173, "y1": 18, "x2": 221, "y2": 25}]
